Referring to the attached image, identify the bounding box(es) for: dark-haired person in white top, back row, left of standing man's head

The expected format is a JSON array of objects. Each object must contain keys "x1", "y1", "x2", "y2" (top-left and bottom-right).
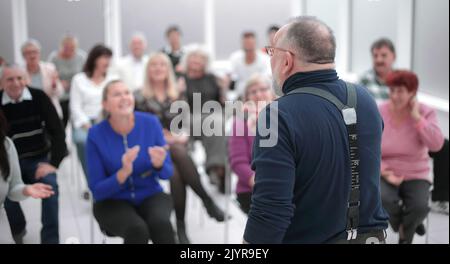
[{"x1": 230, "y1": 32, "x2": 271, "y2": 99}]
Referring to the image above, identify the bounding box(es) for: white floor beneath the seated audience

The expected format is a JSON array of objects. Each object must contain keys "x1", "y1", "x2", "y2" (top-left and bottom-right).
[{"x1": 7, "y1": 141, "x2": 449, "y2": 244}]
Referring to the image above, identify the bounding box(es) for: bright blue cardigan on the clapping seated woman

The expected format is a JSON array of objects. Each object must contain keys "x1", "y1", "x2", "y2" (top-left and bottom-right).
[{"x1": 86, "y1": 112, "x2": 173, "y2": 205}]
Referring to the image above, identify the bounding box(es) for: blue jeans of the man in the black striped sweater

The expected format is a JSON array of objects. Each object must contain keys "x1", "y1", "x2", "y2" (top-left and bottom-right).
[{"x1": 5, "y1": 156, "x2": 59, "y2": 244}]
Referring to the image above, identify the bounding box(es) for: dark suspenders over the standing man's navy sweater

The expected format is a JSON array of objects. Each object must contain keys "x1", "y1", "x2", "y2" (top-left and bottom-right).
[{"x1": 286, "y1": 83, "x2": 361, "y2": 240}]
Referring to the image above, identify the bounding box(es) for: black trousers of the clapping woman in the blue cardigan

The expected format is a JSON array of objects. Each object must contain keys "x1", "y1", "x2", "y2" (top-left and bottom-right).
[{"x1": 94, "y1": 192, "x2": 175, "y2": 244}]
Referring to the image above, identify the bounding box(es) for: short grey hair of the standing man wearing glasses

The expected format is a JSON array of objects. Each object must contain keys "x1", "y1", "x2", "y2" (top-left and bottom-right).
[{"x1": 283, "y1": 16, "x2": 336, "y2": 64}]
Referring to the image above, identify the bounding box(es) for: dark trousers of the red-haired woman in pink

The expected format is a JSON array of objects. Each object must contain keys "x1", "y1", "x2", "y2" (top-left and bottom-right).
[{"x1": 381, "y1": 178, "x2": 430, "y2": 243}]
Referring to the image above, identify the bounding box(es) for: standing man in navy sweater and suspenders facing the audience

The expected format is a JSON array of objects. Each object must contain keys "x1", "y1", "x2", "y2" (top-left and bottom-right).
[{"x1": 244, "y1": 17, "x2": 388, "y2": 244}]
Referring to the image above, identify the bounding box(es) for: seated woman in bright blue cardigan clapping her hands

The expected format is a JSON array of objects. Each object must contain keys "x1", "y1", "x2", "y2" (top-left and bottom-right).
[{"x1": 86, "y1": 81, "x2": 175, "y2": 244}]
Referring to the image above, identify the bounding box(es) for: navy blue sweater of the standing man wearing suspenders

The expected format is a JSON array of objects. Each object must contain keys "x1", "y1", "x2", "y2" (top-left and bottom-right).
[{"x1": 244, "y1": 70, "x2": 388, "y2": 244}]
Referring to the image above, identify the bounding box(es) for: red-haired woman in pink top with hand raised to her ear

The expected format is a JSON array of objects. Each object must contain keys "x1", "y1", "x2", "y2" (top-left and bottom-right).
[{"x1": 380, "y1": 71, "x2": 444, "y2": 243}]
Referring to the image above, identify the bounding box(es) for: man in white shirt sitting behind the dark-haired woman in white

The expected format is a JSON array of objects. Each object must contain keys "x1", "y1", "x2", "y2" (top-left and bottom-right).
[{"x1": 112, "y1": 32, "x2": 148, "y2": 91}]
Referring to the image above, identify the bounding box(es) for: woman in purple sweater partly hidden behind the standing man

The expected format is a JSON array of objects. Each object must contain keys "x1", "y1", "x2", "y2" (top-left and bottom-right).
[{"x1": 228, "y1": 75, "x2": 275, "y2": 214}]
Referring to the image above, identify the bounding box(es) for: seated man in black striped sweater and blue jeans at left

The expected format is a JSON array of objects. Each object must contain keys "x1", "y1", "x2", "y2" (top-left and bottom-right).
[{"x1": 0, "y1": 65, "x2": 67, "y2": 244}]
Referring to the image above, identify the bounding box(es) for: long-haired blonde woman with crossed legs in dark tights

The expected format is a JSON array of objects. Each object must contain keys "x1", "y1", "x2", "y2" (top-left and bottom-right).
[{"x1": 135, "y1": 53, "x2": 224, "y2": 244}]
